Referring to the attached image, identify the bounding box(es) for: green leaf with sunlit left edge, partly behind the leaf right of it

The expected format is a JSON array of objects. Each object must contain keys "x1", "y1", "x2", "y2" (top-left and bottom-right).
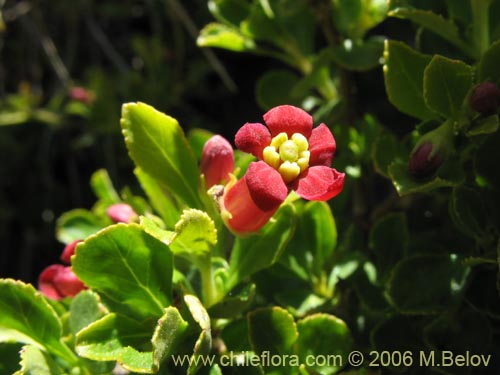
[{"x1": 384, "y1": 40, "x2": 435, "y2": 120}]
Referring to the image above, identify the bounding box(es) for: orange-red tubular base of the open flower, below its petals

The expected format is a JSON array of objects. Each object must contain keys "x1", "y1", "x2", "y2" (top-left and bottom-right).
[{"x1": 221, "y1": 178, "x2": 279, "y2": 235}]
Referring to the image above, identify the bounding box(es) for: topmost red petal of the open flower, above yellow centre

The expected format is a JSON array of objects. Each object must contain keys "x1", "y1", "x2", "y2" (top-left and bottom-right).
[{"x1": 264, "y1": 105, "x2": 312, "y2": 138}]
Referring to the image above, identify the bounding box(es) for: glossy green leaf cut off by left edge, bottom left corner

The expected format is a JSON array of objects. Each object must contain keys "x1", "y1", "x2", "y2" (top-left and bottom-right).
[{"x1": 0, "y1": 279, "x2": 75, "y2": 362}]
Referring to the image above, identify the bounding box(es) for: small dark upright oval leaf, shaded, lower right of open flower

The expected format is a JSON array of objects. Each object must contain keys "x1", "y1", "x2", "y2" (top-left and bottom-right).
[{"x1": 369, "y1": 213, "x2": 409, "y2": 282}]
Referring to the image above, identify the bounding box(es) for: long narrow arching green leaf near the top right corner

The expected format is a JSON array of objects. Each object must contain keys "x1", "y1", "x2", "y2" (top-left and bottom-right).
[{"x1": 389, "y1": 8, "x2": 476, "y2": 57}]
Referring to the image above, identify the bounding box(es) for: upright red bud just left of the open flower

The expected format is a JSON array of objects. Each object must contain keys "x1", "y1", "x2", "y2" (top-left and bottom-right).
[{"x1": 200, "y1": 135, "x2": 234, "y2": 189}]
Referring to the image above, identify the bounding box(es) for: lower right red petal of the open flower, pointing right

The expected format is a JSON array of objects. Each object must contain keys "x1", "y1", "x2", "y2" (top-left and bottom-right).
[{"x1": 295, "y1": 165, "x2": 345, "y2": 201}]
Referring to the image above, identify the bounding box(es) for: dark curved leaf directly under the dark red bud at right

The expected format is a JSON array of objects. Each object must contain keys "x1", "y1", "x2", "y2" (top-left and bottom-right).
[{"x1": 389, "y1": 160, "x2": 465, "y2": 196}]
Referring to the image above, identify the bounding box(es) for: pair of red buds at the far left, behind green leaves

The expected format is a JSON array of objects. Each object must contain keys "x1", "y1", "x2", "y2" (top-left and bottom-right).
[{"x1": 38, "y1": 240, "x2": 86, "y2": 300}]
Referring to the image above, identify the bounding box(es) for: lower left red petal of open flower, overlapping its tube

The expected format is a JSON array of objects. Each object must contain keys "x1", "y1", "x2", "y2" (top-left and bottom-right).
[{"x1": 244, "y1": 161, "x2": 288, "y2": 211}]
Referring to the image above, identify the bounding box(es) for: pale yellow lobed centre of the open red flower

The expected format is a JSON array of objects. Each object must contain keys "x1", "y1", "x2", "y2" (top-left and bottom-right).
[{"x1": 262, "y1": 133, "x2": 310, "y2": 183}]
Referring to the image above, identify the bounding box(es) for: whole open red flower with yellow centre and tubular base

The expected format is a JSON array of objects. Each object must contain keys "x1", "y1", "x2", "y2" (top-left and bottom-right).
[{"x1": 223, "y1": 105, "x2": 344, "y2": 232}]
